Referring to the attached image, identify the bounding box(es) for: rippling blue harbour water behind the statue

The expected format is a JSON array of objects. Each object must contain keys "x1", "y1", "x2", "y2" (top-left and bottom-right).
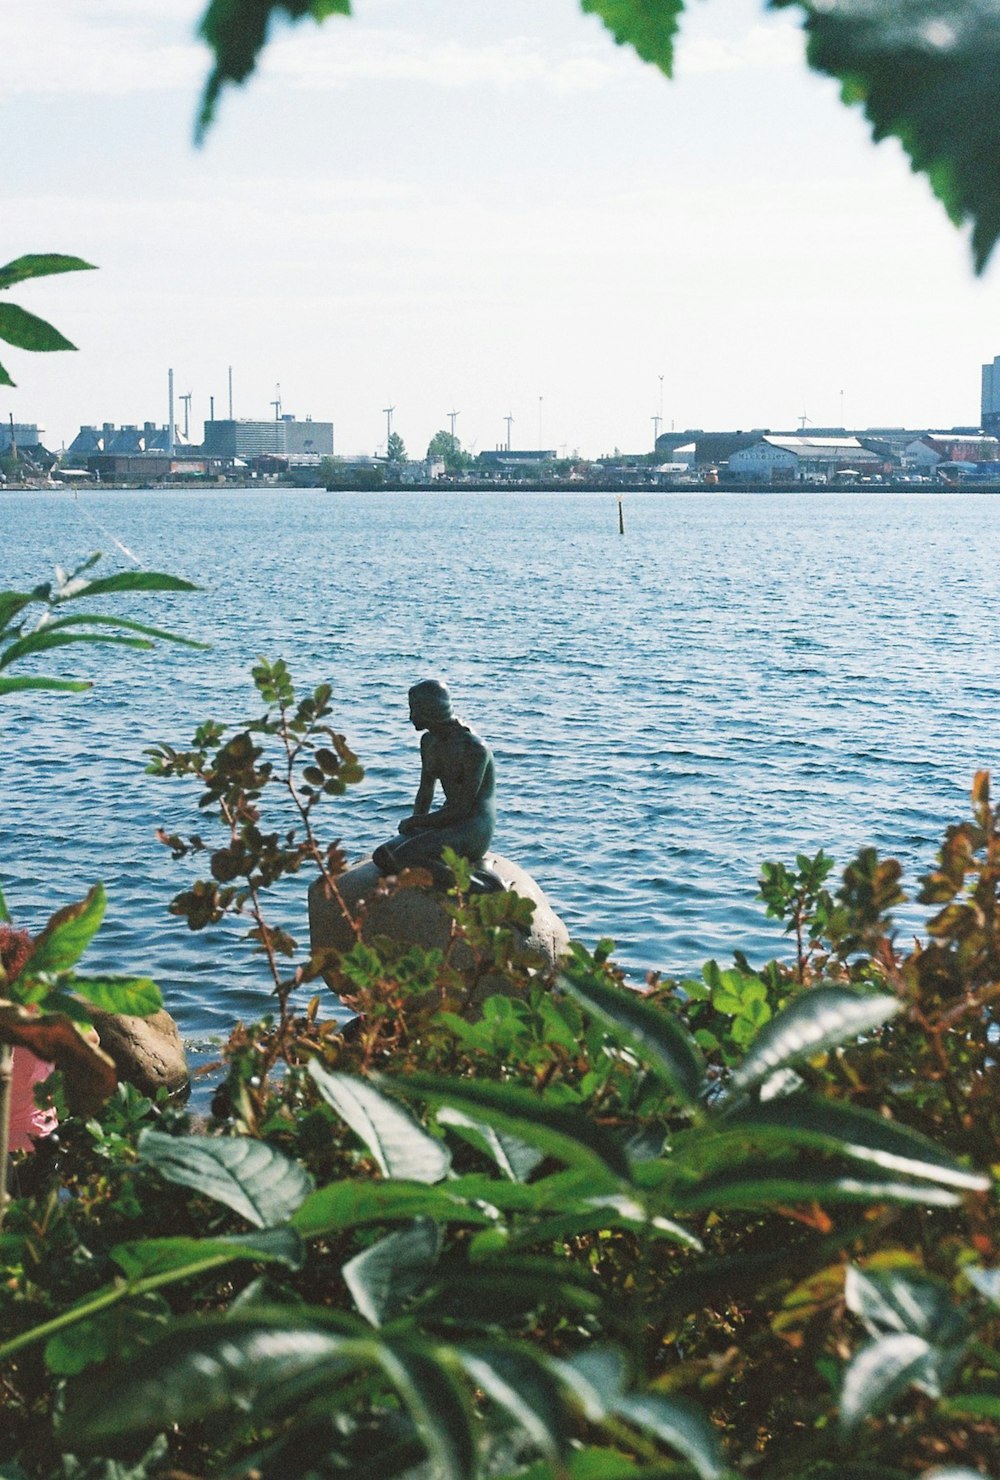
[{"x1": 0, "y1": 490, "x2": 1000, "y2": 1040}]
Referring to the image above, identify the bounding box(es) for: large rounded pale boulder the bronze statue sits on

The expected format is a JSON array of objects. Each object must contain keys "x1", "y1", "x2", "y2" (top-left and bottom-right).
[{"x1": 309, "y1": 852, "x2": 570, "y2": 1015}]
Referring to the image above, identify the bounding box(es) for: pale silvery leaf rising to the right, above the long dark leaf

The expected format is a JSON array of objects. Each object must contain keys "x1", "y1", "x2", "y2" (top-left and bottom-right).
[{"x1": 718, "y1": 987, "x2": 899, "y2": 1097}]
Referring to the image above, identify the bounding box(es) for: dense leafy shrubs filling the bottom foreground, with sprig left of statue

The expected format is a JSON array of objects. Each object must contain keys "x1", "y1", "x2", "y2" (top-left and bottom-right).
[{"x1": 0, "y1": 663, "x2": 1000, "y2": 1480}]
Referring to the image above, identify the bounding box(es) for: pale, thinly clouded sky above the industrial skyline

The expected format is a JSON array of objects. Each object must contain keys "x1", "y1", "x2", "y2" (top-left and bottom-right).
[{"x1": 0, "y1": 0, "x2": 1000, "y2": 456}]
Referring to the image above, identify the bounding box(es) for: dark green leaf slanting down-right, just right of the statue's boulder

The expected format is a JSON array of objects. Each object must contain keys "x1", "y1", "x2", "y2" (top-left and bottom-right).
[{"x1": 559, "y1": 972, "x2": 704, "y2": 1107}]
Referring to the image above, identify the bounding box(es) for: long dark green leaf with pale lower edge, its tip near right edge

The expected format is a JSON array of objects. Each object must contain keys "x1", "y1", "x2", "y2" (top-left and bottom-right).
[{"x1": 672, "y1": 1094, "x2": 990, "y2": 1191}]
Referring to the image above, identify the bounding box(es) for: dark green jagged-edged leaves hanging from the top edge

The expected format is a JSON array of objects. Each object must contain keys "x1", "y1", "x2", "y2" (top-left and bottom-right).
[{"x1": 198, "y1": 0, "x2": 1000, "y2": 271}]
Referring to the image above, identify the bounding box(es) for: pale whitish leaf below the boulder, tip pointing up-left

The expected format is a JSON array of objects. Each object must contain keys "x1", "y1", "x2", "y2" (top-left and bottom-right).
[{"x1": 309, "y1": 1058, "x2": 451, "y2": 1183}]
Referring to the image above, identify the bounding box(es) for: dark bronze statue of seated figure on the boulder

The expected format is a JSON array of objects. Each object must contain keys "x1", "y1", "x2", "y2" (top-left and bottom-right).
[{"x1": 371, "y1": 678, "x2": 504, "y2": 889}]
